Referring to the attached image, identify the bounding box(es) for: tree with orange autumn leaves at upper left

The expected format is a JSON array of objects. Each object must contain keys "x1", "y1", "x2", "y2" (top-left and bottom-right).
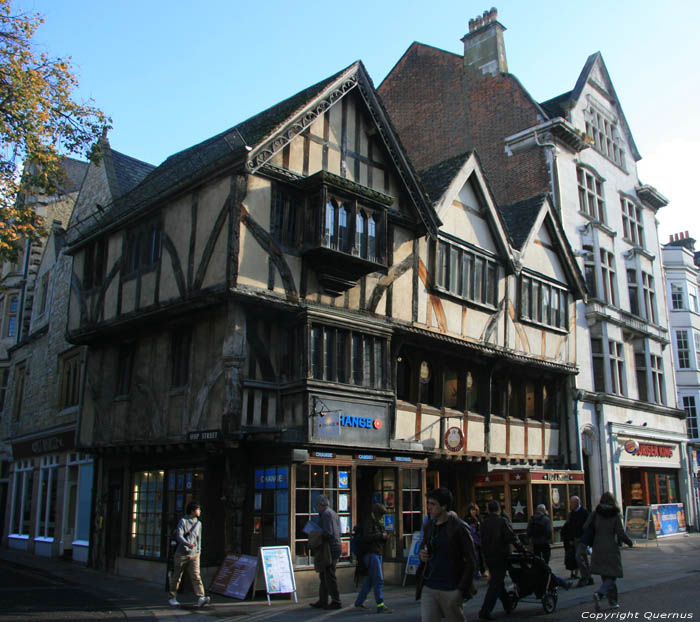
[{"x1": 0, "y1": 0, "x2": 110, "y2": 261}]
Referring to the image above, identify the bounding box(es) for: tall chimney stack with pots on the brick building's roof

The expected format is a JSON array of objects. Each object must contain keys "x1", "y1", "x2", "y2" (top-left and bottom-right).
[{"x1": 462, "y1": 7, "x2": 508, "y2": 75}]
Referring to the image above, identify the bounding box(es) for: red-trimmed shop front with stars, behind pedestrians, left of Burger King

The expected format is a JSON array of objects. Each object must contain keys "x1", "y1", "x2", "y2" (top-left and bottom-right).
[{"x1": 474, "y1": 471, "x2": 585, "y2": 542}]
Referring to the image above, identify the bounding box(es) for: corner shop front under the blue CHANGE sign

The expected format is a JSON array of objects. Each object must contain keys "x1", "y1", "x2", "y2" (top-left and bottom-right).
[{"x1": 248, "y1": 396, "x2": 427, "y2": 594}]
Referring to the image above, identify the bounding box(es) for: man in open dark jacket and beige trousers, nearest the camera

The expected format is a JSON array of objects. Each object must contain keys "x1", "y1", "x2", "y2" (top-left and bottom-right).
[{"x1": 416, "y1": 488, "x2": 477, "y2": 622}]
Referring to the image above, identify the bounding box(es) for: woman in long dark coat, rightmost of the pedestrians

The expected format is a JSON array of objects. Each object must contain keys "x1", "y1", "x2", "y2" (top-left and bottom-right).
[{"x1": 584, "y1": 492, "x2": 633, "y2": 613}]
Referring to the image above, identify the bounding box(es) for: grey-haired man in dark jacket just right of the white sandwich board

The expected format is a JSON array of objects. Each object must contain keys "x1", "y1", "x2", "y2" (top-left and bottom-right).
[{"x1": 309, "y1": 495, "x2": 343, "y2": 609}]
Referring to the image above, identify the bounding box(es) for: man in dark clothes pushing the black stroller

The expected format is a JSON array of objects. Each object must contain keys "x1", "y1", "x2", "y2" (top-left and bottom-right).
[{"x1": 479, "y1": 499, "x2": 525, "y2": 620}]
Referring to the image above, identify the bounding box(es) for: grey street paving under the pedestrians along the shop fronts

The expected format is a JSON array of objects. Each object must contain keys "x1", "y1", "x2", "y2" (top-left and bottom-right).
[{"x1": 0, "y1": 534, "x2": 700, "y2": 622}]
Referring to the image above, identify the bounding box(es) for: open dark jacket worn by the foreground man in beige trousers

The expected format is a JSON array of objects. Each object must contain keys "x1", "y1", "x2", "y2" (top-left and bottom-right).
[{"x1": 416, "y1": 512, "x2": 477, "y2": 600}]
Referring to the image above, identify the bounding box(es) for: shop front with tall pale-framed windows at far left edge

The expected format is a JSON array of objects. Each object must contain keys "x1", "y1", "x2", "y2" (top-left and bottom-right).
[{"x1": 5, "y1": 426, "x2": 93, "y2": 562}]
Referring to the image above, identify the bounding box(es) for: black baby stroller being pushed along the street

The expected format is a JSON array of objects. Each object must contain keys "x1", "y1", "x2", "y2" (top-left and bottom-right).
[{"x1": 508, "y1": 552, "x2": 557, "y2": 613}]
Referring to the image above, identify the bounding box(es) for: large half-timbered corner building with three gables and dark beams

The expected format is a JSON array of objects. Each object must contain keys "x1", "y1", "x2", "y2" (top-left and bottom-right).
[{"x1": 61, "y1": 62, "x2": 583, "y2": 593}]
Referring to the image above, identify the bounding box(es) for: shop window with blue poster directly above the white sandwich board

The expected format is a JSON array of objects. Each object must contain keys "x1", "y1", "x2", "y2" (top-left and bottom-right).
[{"x1": 252, "y1": 466, "x2": 289, "y2": 549}]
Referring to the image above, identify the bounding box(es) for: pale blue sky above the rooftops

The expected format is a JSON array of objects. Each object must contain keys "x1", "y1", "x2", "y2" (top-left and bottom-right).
[{"x1": 12, "y1": 0, "x2": 700, "y2": 248}]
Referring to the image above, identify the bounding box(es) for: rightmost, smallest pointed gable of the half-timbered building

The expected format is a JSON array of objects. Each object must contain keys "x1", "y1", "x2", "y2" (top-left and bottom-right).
[{"x1": 498, "y1": 194, "x2": 586, "y2": 299}]
